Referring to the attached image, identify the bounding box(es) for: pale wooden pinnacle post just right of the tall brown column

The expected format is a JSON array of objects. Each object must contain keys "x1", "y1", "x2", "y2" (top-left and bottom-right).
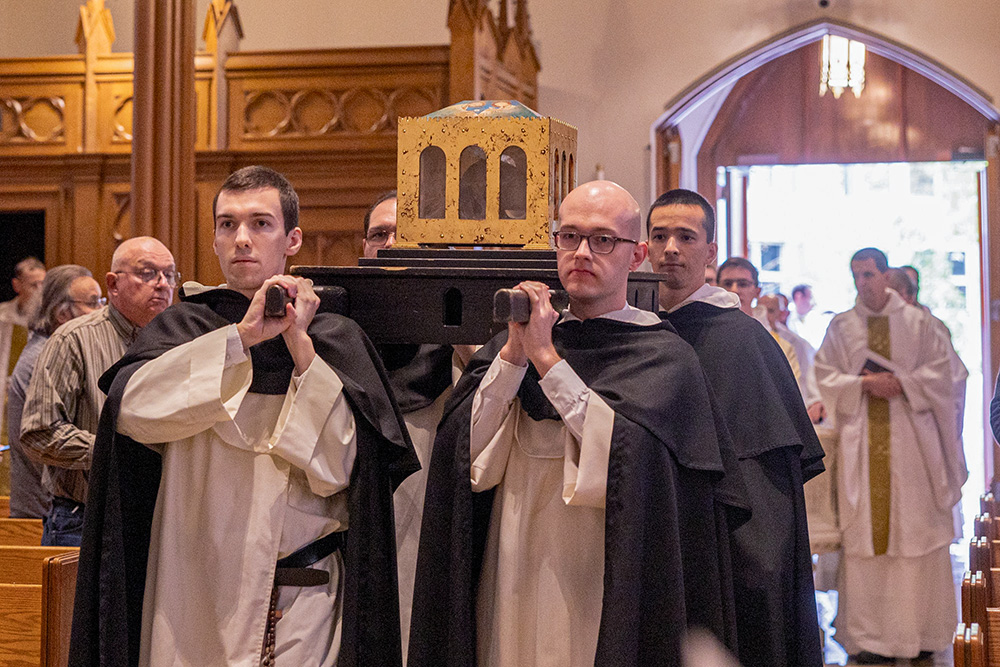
[{"x1": 202, "y1": 0, "x2": 243, "y2": 150}]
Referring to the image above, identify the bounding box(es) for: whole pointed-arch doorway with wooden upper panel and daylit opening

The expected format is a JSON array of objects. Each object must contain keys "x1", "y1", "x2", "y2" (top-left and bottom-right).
[{"x1": 650, "y1": 21, "x2": 1000, "y2": 663}]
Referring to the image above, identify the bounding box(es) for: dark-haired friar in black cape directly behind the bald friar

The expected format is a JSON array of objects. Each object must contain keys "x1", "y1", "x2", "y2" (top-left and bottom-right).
[{"x1": 646, "y1": 189, "x2": 823, "y2": 667}]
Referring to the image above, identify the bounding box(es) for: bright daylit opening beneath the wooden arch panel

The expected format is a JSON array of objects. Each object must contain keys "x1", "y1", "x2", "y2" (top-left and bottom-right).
[{"x1": 740, "y1": 160, "x2": 989, "y2": 536}]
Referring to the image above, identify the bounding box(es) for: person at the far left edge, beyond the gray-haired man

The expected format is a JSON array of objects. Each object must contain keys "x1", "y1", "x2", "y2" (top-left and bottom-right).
[{"x1": 0, "y1": 257, "x2": 45, "y2": 444}]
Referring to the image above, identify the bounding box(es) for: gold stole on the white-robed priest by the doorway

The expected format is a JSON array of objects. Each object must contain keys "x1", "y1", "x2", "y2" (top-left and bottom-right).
[{"x1": 868, "y1": 315, "x2": 892, "y2": 556}]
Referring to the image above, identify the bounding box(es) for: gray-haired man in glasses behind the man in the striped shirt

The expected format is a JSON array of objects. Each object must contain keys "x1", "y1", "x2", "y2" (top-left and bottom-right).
[{"x1": 7, "y1": 264, "x2": 104, "y2": 519}]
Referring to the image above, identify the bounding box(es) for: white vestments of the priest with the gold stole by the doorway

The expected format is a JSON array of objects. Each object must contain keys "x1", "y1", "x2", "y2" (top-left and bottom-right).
[{"x1": 816, "y1": 290, "x2": 968, "y2": 658}]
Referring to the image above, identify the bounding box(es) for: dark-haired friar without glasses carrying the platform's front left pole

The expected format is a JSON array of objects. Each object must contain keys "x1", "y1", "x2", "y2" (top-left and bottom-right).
[{"x1": 70, "y1": 166, "x2": 415, "y2": 667}]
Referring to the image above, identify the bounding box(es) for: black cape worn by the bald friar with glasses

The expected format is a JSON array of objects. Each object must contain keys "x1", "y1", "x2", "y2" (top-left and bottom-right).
[{"x1": 408, "y1": 319, "x2": 745, "y2": 667}]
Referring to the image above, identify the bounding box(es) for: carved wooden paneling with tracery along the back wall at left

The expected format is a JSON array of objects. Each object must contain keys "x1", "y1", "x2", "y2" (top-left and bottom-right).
[{"x1": 0, "y1": 0, "x2": 539, "y2": 282}]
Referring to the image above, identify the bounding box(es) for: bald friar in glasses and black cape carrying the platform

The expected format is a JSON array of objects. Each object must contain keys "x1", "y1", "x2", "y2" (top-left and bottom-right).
[{"x1": 409, "y1": 181, "x2": 748, "y2": 667}]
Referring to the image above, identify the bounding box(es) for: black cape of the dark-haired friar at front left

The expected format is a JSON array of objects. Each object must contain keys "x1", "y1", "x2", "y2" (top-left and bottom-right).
[{"x1": 69, "y1": 289, "x2": 419, "y2": 667}]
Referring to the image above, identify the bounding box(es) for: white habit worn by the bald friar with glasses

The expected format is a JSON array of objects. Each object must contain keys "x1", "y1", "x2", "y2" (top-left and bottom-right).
[{"x1": 470, "y1": 306, "x2": 660, "y2": 667}]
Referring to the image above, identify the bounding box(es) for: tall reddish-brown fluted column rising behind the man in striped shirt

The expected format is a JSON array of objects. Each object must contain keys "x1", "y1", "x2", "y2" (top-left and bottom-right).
[{"x1": 132, "y1": 0, "x2": 196, "y2": 276}]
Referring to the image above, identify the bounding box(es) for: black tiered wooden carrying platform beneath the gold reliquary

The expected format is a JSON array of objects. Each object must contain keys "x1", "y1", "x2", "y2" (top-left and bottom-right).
[{"x1": 291, "y1": 249, "x2": 662, "y2": 345}]
